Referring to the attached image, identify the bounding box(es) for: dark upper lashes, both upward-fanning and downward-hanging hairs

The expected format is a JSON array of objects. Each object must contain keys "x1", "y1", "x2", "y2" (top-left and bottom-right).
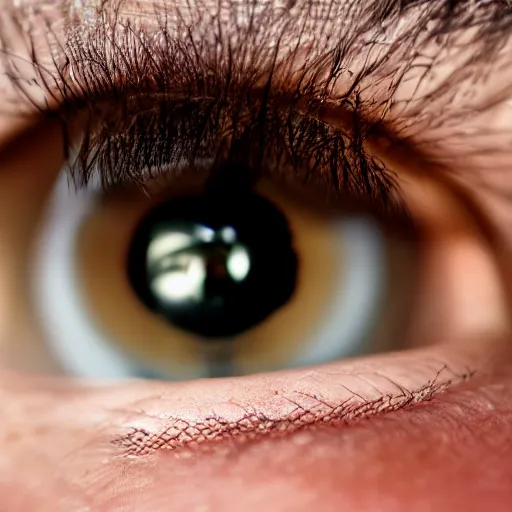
[{"x1": 54, "y1": 15, "x2": 400, "y2": 211}]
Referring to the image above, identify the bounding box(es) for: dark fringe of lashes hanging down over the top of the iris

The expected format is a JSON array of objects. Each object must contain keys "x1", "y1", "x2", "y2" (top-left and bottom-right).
[{"x1": 61, "y1": 92, "x2": 393, "y2": 203}]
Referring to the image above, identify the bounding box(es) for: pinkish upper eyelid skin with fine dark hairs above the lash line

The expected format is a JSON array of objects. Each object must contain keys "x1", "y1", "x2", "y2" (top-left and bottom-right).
[{"x1": 0, "y1": 0, "x2": 512, "y2": 192}]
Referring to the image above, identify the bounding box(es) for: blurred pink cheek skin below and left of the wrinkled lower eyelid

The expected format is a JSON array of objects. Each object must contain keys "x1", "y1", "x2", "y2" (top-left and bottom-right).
[{"x1": 0, "y1": 368, "x2": 512, "y2": 512}]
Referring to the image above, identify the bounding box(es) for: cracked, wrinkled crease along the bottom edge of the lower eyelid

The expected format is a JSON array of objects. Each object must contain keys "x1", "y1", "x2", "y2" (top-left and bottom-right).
[{"x1": 111, "y1": 366, "x2": 475, "y2": 456}]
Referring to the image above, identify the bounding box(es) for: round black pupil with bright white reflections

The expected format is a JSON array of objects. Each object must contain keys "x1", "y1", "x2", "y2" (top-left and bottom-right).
[{"x1": 128, "y1": 193, "x2": 297, "y2": 338}]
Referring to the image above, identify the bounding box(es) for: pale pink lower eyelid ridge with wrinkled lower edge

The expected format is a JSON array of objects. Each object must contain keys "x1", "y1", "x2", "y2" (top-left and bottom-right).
[{"x1": 110, "y1": 343, "x2": 490, "y2": 456}]
